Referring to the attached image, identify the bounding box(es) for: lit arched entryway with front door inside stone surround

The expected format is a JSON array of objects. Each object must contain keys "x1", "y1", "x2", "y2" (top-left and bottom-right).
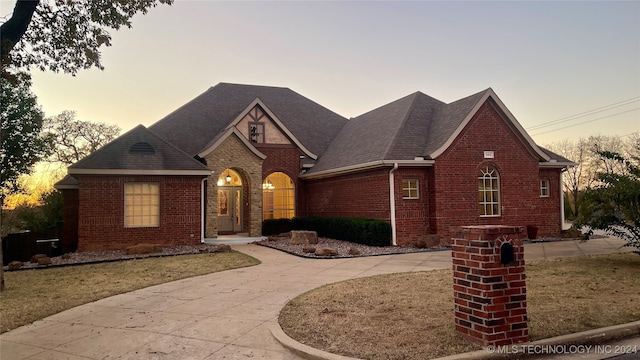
[{"x1": 216, "y1": 169, "x2": 244, "y2": 234}]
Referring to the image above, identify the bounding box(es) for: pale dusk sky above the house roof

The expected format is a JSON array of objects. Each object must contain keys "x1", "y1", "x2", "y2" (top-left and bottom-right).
[{"x1": 8, "y1": 0, "x2": 640, "y2": 145}]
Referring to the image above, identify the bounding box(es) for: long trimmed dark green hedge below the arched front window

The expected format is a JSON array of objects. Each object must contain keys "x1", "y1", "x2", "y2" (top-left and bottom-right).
[{"x1": 262, "y1": 217, "x2": 391, "y2": 246}]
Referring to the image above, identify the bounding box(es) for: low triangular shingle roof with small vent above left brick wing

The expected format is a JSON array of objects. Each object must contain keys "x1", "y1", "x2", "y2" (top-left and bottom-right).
[{"x1": 69, "y1": 125, "x2": 208, "y2": 174}]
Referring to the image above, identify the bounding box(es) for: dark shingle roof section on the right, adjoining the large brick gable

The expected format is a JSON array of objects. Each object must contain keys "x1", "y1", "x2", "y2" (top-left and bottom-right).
[{"x1": 309, "y1": 90, "x2": 496, "y2": 174}]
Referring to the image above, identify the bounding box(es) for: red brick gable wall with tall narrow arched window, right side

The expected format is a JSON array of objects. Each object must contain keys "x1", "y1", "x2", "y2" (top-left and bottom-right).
[{"x1": 429, "y1": 103, "x2": 561, "y2": 239}]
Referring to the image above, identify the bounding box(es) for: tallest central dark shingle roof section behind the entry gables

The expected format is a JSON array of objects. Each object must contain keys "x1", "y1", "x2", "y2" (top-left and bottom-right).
[{"x1": 150, "y1": 83, "x2": 347, "y2": 156}]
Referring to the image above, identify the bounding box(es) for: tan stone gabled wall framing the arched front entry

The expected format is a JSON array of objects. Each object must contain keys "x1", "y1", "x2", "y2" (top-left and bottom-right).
[{"x1": 205, "y1": 135, "x2": 263, "y2": 238}]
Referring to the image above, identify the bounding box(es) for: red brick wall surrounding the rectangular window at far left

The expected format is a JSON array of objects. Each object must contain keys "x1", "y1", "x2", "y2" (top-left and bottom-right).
[{"x1": 77, "y1": 175, "x2": 202, "y2": 251}]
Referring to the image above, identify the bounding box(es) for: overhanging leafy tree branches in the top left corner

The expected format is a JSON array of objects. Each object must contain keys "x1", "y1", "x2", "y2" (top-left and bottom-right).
[{"x1": 0, "y1": 0, "x2": 173, "y2": 78}]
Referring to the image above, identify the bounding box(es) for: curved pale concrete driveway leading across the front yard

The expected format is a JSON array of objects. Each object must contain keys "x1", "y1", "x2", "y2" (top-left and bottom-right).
[{"x1": 0, "y1": 238, "x2": 631, "y2": 360}]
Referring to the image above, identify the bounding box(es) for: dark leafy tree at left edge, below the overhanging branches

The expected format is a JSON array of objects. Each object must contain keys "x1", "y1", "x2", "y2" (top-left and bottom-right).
[{"x1": 0, "y1": 79, "x2": 51, "y2": 202}]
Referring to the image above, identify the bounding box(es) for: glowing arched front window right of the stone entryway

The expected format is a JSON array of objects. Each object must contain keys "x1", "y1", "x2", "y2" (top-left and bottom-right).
[{"x1": 262, "y1": 172, "x2": 295, "y2": 220}]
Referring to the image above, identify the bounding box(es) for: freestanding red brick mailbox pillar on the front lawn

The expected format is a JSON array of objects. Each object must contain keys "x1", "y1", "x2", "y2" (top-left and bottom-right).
[{"x1": 451, "y1": 225, "x2": 529, "y2": 347}]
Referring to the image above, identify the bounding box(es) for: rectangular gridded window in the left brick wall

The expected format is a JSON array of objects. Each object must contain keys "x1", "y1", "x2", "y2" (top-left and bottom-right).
[{"x1": 124, "y1": 183, "x2": 160, "y2": 227}]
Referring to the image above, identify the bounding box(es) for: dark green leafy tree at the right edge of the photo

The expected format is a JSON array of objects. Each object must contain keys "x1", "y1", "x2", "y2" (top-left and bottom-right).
[{"x1": 574, "y1": 148, "x2": 640, "y2": 252}]
